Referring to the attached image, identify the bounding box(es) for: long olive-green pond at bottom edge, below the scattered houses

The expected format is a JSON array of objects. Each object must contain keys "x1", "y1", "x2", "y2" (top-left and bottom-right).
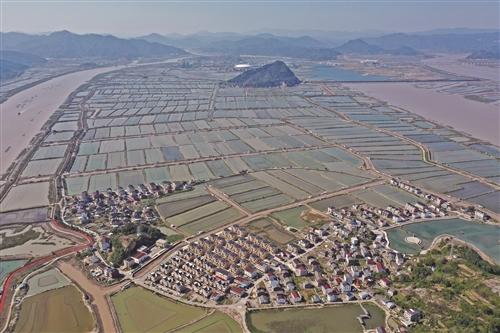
[{"x1": 247, "y1": 304, "x2": 385, "y2": 333}]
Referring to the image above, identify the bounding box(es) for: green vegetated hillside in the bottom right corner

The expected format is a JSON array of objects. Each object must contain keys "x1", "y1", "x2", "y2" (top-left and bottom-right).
[{"x1": 394, "y1": 245, "x2": 500, "y2": 332}]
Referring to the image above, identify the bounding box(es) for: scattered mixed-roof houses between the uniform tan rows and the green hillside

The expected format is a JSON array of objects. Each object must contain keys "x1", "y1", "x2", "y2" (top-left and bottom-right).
[{"x1": 252, "y1": 218, "x2": 404, "y2": 305}]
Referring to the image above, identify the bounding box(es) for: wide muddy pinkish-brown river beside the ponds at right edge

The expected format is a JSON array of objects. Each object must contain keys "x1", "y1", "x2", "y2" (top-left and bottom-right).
[{"x1": 345, "y1": 82, "x2": 500, "y2": 145}]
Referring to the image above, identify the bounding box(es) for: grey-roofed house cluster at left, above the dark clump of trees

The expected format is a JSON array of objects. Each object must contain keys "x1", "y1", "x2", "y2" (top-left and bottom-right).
[{"x1": 64, "y1": 181, "x2": 199, "y2": 228}]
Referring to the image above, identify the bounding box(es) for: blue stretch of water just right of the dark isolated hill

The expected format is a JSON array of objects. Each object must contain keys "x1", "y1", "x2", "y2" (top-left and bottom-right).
[{"x1": 310, "y1": 65, "x2": 390, "y2": 82}]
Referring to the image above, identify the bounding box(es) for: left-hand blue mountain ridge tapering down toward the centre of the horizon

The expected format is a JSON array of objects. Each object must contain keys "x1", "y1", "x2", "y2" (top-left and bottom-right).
[{"x1": 0, "y1": 31, "x2": 187, "y2": 59}]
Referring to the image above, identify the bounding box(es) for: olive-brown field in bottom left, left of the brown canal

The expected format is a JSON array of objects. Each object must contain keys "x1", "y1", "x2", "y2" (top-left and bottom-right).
[{"x1": 14, "y1": 285, "x2": 95, "y2": 333}]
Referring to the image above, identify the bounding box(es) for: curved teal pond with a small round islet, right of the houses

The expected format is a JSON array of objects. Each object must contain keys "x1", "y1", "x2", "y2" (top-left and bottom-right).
[{"x1": 387, "y1": 218, "x2": 500, "y2": 262}]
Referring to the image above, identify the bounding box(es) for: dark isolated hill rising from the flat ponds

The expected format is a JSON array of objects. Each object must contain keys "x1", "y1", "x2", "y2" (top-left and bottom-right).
[{"x1": 228, "y1": 60, "x2": 300, "y2": 88}]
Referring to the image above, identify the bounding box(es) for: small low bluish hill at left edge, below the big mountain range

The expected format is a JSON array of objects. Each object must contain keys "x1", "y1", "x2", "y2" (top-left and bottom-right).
[{"x1": 0, "y1": 50, "x2": 47, "y2": 80}]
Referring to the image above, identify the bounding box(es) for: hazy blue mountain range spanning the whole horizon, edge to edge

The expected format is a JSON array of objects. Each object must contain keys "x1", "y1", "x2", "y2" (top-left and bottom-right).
[{"x1": 0, "y1": 28, "x2": 500, "y2": 65}]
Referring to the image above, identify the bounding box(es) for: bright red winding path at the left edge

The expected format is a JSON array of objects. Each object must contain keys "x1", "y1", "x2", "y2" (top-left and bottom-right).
[{"x1": 0, "y1": 219, "x2": 94, "y2": 313}]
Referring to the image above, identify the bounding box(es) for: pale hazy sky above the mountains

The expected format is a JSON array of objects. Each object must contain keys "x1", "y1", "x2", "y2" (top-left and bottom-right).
[{"x1": 0, "y1": 0, "x2": 499, "y2": 36}]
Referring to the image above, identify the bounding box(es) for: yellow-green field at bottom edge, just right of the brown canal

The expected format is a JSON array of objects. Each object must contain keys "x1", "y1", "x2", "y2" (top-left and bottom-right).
[{"x1": 111, "y1": 287, "x2": 206, "y2": 333}]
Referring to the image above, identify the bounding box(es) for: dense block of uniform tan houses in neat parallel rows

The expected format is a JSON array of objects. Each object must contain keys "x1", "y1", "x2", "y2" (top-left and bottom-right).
[{"x1": 147, "y1": 225, "x2": 283, "y2": 302}]
